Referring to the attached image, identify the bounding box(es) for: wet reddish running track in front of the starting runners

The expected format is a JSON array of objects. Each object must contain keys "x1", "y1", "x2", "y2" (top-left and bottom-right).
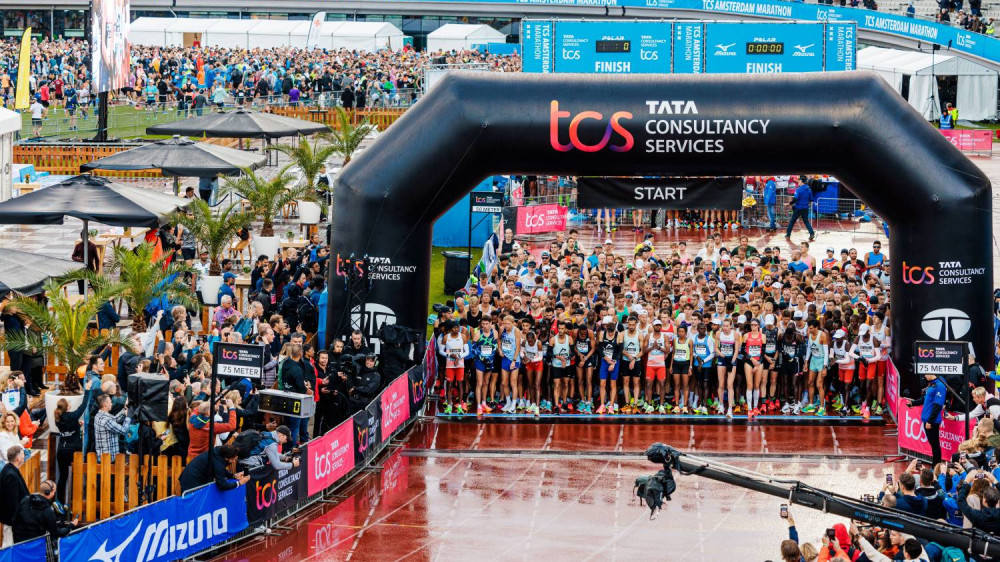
[{"x1": 217, "y1": 422, "x2": 900, "y2": 562}]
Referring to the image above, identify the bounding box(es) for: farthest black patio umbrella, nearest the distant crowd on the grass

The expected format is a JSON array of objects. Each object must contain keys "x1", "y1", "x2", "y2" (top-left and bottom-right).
[{"x1": 146, "y1": 109, "x2": 330, "y2": 139}]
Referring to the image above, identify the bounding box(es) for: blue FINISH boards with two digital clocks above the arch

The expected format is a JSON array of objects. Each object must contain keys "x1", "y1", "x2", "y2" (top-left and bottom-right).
[{"x1": 522, "y1": 20, "x2": 857, "y2": 74}]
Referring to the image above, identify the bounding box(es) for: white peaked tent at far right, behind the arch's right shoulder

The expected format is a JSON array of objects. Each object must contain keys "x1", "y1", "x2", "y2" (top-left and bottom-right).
[{"x1": 858, "y1": 47, "x2": 998, "y2": 121}]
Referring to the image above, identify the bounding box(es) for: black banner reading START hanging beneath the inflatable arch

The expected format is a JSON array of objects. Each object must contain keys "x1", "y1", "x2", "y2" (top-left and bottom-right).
[{"x1": 576, "y1": 178, "x2": 743, "y2": 211}]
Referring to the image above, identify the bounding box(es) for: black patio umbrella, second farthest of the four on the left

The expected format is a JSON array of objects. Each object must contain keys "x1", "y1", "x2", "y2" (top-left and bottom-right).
[{"x1": 80, "y1": 135, "x2": 267, "y2": 195}]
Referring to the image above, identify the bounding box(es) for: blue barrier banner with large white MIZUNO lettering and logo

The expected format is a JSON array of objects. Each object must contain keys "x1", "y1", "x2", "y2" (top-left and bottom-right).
[{"x1": 59, "y1": 485, "x2": 247, "y2": 562}]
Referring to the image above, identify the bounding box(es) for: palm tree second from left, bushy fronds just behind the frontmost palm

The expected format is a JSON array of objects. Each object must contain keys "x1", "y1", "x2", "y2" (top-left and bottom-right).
[{"x1": 110, "y1": 243, "x2": 199, "y2": 332}]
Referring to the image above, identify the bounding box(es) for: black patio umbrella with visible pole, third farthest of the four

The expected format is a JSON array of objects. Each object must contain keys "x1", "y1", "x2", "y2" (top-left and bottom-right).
[{"x1": 0, "y1": 175, "x2": 193, "y2": 288}]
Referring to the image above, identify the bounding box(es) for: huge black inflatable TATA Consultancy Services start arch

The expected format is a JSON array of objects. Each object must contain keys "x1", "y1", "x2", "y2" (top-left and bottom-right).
[{"x1": 328, "y1": 72, "x2": 993, "y2": 384}]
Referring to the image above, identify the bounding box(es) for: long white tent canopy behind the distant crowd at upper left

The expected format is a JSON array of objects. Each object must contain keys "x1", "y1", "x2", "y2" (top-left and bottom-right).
[{"x1": 131, "y1": 17, "x2": 403, "y2": 51}]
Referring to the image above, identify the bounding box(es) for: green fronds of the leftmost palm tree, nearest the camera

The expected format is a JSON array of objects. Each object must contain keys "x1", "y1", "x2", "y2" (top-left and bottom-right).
[{"x1": 0, "y1": 270, "x2": 132, "y2": 373}]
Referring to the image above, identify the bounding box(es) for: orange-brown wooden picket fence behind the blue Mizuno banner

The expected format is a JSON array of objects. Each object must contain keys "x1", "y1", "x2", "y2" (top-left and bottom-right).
[{"x1": 70, "y1": 452, "x2": 184, "y2": 523}]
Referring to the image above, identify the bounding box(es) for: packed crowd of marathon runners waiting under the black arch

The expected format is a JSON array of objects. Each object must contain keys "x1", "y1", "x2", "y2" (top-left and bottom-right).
[{"x1": 434, "y1": 217, "x2": 891, "y2": 418}]
